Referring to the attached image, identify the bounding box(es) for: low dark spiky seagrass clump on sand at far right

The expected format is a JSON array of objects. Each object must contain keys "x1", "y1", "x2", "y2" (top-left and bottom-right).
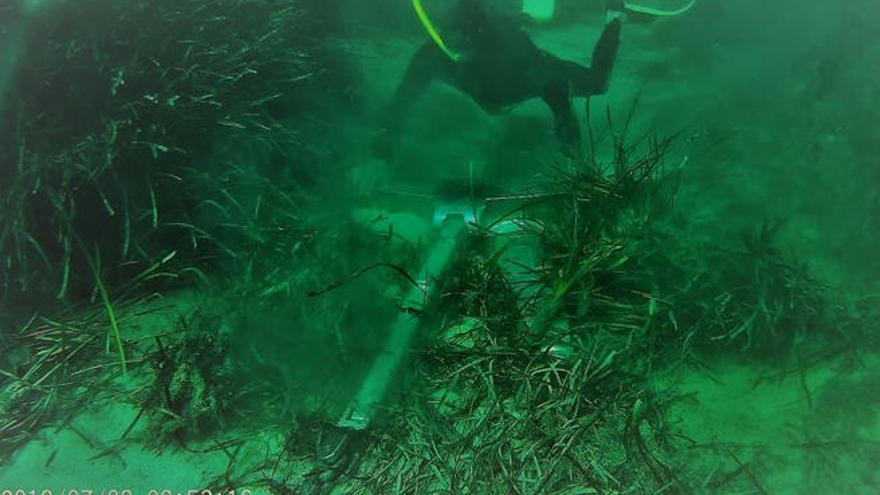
[{"x1": 677, "y1": 221, "x2": 864, "y2": 357}]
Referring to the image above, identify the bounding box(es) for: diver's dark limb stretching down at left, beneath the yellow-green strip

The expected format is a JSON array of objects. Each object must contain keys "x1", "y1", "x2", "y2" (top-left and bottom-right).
[{"x1": 374, "y1": 43, "x2": 451, "y2": 157}]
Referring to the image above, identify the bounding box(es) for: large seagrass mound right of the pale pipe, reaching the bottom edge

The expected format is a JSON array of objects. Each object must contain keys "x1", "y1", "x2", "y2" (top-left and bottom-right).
[{"x1": 324, "y1": 126, "x2": 686, "y2": 494}]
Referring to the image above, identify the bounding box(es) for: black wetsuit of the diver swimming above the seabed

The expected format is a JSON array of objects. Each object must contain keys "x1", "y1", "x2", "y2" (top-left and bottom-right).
[{"x1": 383, "y1": 0, "x2": 620, "y2": 155}]
